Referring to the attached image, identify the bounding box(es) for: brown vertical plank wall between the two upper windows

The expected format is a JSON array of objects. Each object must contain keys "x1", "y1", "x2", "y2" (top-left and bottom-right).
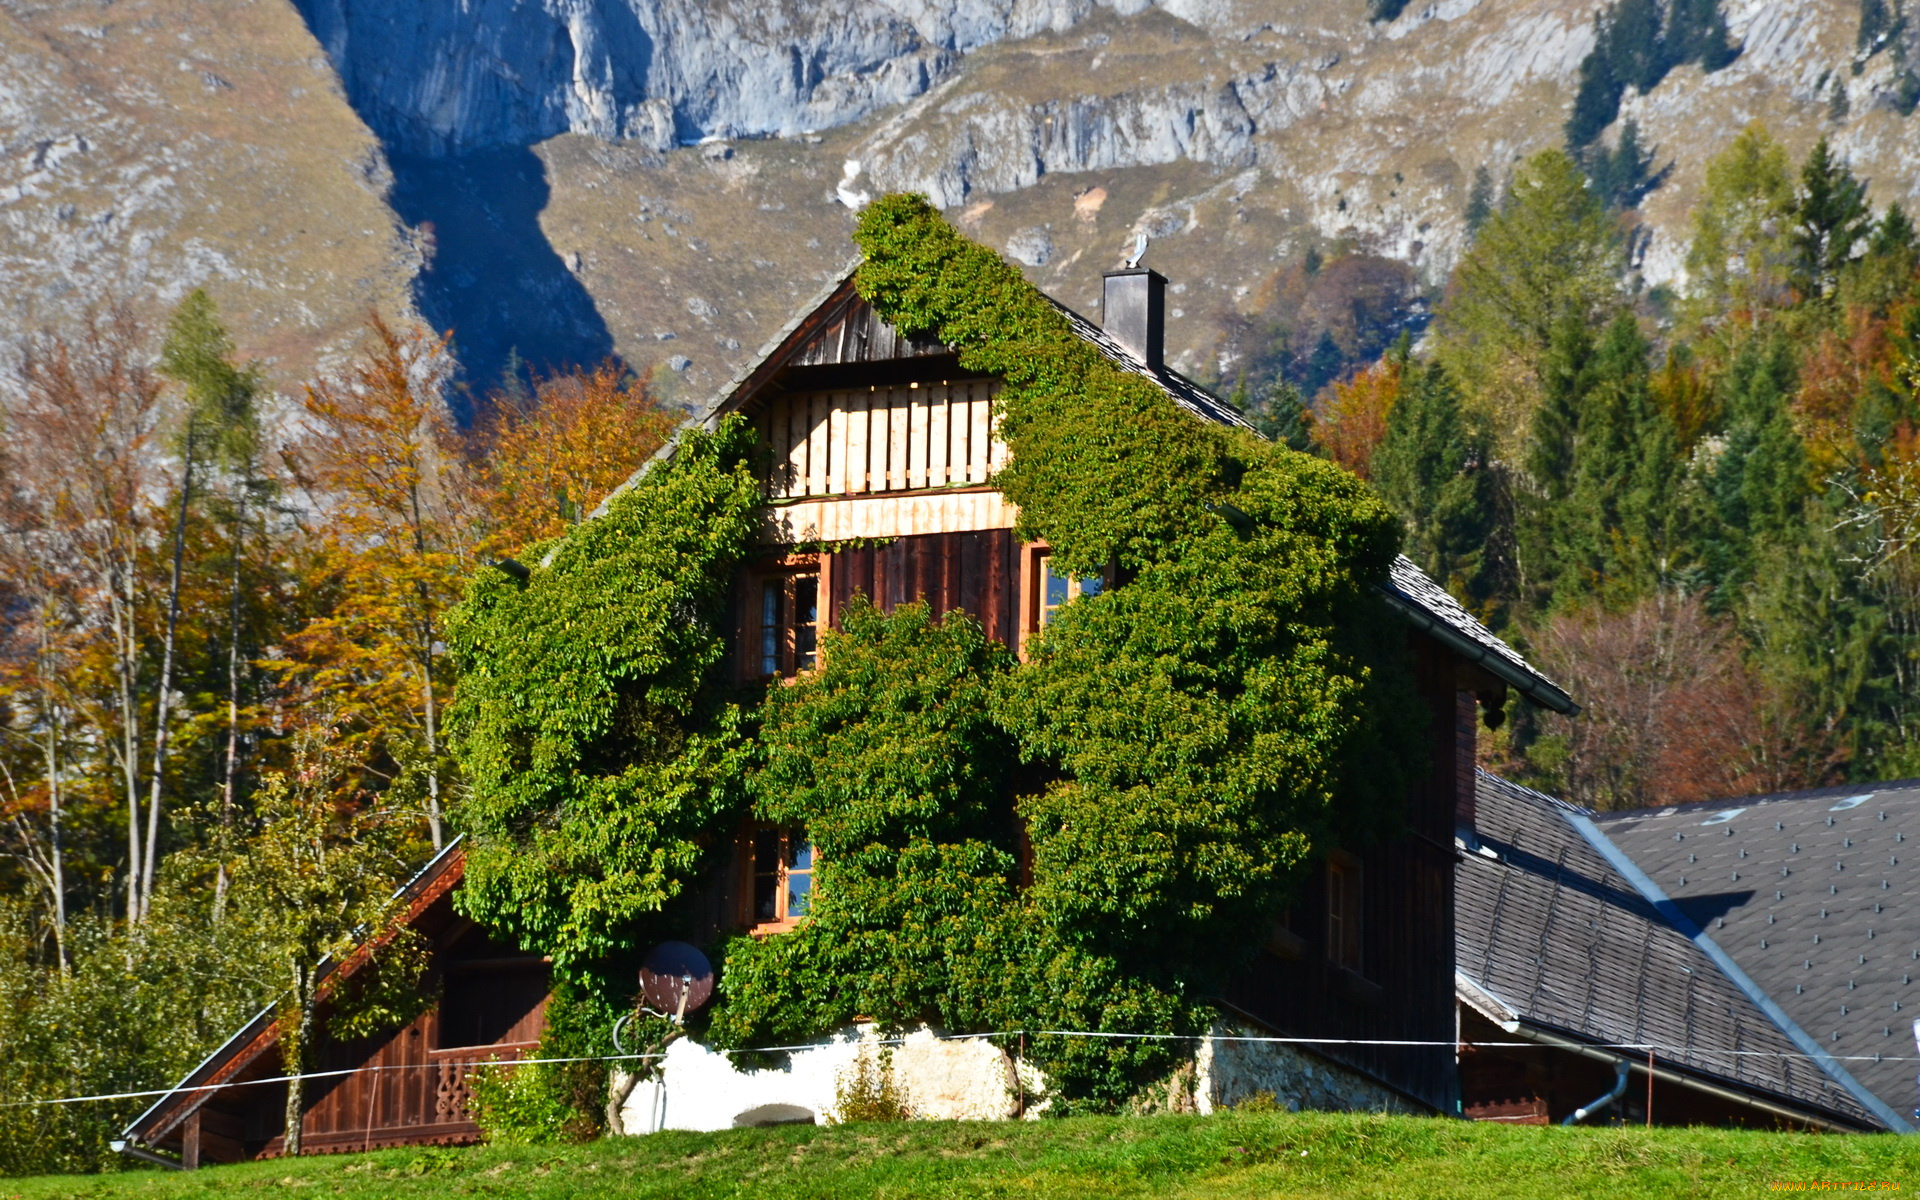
[{"x1": 828, "y1": 530, "x2": 1020, "y2": 645}]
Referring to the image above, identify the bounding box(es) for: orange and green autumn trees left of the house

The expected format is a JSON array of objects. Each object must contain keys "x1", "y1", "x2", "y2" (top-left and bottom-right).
[{"x1": 0, "y1": 301, "x2": 676, "y2": 1173}]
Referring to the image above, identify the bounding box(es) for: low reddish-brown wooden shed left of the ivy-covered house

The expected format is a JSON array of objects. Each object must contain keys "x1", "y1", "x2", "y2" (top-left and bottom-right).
[{"x1": 119, "y1": 843, "x2": 549, "y2": 1169}]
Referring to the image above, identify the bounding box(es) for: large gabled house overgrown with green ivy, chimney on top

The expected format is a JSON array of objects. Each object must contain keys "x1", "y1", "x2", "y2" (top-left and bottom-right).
[{"x1": 449, "y1": 198, "x2": 1574, "y2": 1129}]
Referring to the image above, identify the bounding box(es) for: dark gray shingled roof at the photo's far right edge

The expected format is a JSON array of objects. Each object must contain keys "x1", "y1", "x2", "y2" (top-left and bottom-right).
[{"x1": 1596, "y1": 780, "x2": 1920, "y2": 1114}]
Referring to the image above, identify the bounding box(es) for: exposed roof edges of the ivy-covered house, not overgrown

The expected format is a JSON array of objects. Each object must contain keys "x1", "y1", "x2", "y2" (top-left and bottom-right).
[{"x1": 593, "y1": 259, "x2": 1580, "y2": 716}]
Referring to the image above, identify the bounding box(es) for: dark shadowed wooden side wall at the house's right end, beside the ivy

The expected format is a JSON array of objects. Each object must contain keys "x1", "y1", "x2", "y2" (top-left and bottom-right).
[{"x1": 1227, "y1": 636, "x2": 1473, "y2": 1114}]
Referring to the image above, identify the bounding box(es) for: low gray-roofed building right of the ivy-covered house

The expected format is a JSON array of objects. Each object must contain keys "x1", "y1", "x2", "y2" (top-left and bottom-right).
[{"x1": 1455, "y1": 774, "x2": 1920, "y2": 1133}]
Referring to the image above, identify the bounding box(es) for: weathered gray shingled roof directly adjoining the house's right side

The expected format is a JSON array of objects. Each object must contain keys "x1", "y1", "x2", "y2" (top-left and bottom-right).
[{"x1": 1453, "y1": 772, "x2": 1882, "y2": 1125}]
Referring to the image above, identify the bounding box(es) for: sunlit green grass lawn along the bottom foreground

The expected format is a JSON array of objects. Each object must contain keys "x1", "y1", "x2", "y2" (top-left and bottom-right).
[{"x1": 0, "y1": 1114, "x2": 1920, "y2": 1200}]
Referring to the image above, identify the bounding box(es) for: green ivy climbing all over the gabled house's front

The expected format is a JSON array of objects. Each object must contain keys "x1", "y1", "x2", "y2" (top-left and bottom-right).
[{"x1": 455, "y1": 196, "x2": 1419, "y2": 1112}]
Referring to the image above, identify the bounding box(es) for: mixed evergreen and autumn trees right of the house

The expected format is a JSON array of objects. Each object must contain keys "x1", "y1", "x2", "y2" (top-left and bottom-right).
[{"x1": 1261, "y1": 127, "x2": 1920, "y2": 808}]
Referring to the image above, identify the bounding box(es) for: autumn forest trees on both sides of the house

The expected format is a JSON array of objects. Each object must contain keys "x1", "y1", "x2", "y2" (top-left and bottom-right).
[{"x1": 0, "y1": 109, "x2": 1920, "y2": 1173}]
